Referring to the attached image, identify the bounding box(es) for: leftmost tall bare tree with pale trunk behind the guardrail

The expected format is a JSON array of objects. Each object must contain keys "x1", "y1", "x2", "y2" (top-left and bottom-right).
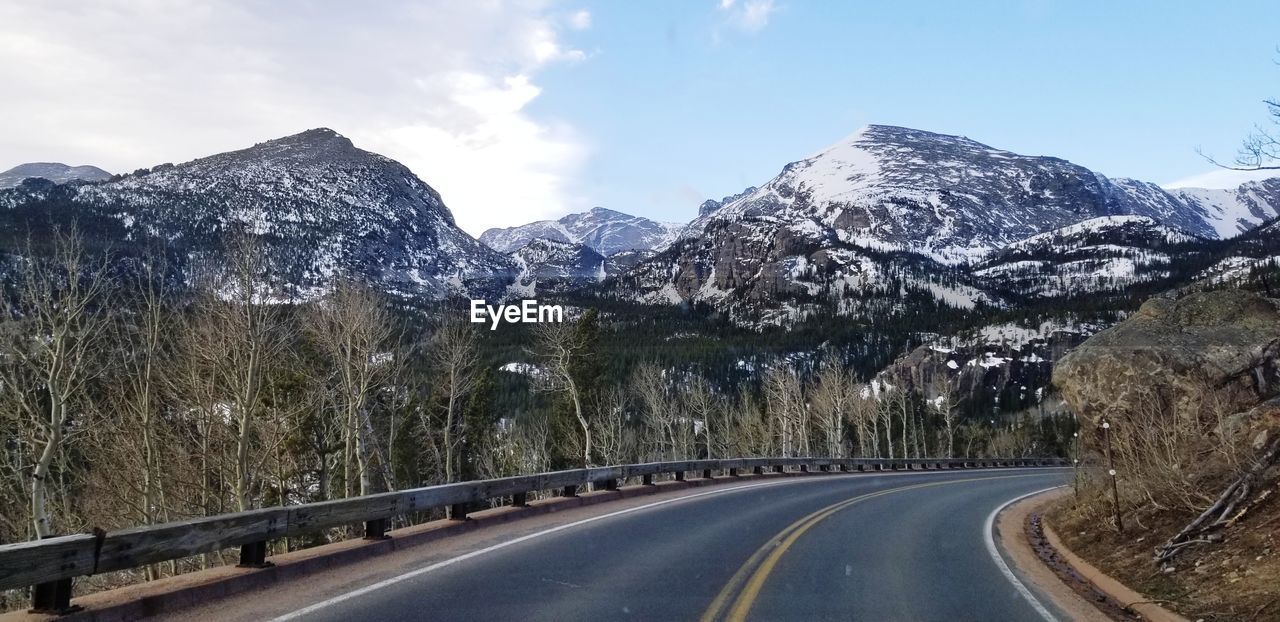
[{"x1": 0, "y1": 229, "x2": 109, "y2": 538}]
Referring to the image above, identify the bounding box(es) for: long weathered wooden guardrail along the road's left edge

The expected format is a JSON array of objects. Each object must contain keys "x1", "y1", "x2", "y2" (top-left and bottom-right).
[{"x1": 0, "y1": 458, "x2": 1066, "y2": 613}]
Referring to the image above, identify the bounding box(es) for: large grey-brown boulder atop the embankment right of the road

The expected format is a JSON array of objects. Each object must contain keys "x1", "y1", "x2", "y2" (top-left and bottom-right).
[{"x1": 1053, "y1": 289, "x2": 1280, "y2": 424}]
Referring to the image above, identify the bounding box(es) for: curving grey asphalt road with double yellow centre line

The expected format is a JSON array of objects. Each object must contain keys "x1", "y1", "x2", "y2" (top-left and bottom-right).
[{"x1": 172, "y1": 470, "x2": 1069, "y2": 622}]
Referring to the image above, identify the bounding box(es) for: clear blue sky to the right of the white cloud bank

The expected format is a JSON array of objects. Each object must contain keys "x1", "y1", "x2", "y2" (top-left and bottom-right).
[{"x1": 529, "y1": 0, "x2": 1280, "y2": 225}]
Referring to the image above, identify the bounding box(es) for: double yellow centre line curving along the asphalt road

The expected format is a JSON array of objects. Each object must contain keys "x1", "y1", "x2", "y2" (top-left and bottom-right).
[{"x1": 699, "y1": 475, "x2": 1036, "y2": 622}]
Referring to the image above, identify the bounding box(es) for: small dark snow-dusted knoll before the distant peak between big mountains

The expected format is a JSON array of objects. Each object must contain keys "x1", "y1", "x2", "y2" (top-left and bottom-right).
[{"x1": 509, "y1": 238, "x2": 605, "y2": 297}]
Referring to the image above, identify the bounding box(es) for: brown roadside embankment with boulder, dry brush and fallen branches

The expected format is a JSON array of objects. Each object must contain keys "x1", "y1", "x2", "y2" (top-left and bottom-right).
[{"x1": 1048, "y1": 291, "x2": 1280, "y2": 621}]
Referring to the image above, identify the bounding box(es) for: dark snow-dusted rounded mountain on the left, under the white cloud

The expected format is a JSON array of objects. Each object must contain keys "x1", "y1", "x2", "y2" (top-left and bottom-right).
[{"x1": 0, "y1": 128, "x2": 516, "y2": 298}]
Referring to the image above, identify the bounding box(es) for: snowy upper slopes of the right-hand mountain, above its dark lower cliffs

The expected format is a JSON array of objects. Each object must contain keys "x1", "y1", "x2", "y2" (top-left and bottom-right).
[{"x1": 686, "y1": 125, "x2": 1280, "y2": 262}]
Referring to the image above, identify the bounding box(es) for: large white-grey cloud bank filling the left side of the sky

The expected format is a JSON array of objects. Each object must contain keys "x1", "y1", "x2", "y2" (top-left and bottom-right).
[{"x1": 0, "y1": 0, "x2": 590, "y2": 233}]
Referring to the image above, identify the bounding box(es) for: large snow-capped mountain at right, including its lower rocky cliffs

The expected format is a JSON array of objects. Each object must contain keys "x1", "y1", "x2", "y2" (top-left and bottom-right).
[{"x1": 618, "y1": 125, "x2": 1280, "y2": 324}]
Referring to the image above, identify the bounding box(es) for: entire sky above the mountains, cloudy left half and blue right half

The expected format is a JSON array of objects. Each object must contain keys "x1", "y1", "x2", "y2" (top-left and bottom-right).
[{"x1": 0, "y1": 0, "x2": 1280, "y2": 234}]
